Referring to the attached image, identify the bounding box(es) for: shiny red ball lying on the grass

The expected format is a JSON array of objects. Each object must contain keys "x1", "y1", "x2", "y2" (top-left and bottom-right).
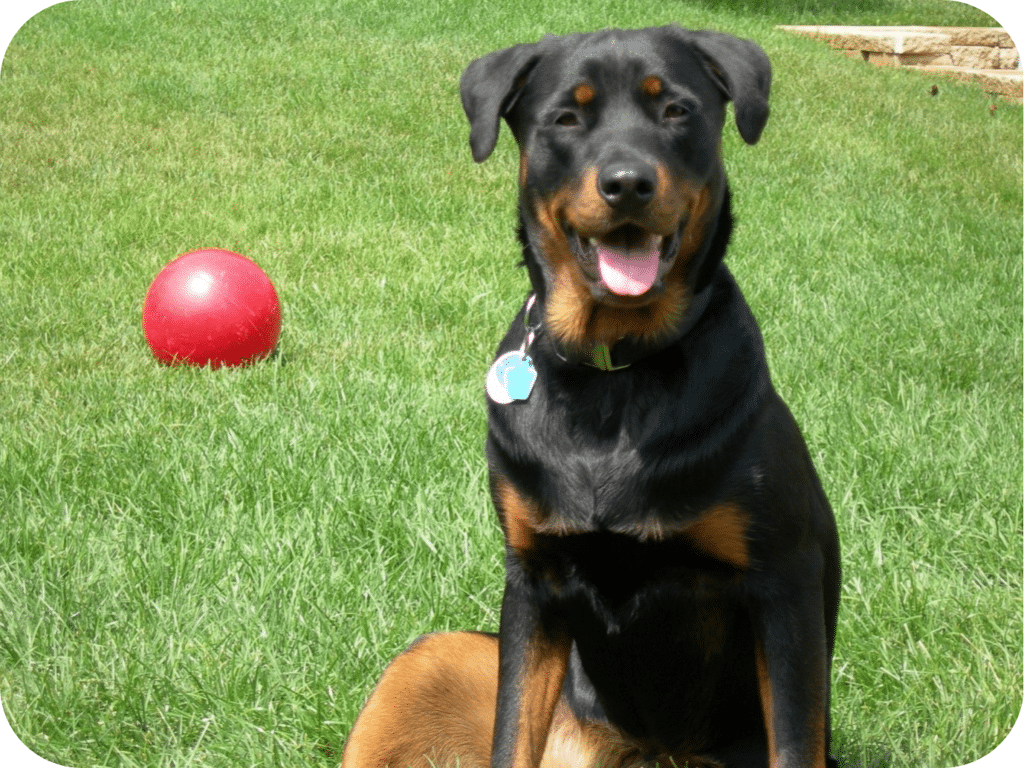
[{"x1": 142, "y1": 248, "x2": 281, "y2": 368}]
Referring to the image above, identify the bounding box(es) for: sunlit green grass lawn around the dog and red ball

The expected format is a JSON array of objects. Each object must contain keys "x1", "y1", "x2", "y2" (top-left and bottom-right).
[{"x1": 0, "y1": 0, "x2": 1024, "y2": 766}]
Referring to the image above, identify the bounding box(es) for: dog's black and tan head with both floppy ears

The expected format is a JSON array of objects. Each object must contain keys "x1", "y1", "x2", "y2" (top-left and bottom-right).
[{"x1": 461, "y1": 27, "x2": 771, "y2": 345}]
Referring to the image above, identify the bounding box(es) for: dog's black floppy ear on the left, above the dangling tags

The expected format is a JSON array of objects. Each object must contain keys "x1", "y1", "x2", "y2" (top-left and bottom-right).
[{"x1": 459, "y1": 43, "x2": 542, "y2": 163}]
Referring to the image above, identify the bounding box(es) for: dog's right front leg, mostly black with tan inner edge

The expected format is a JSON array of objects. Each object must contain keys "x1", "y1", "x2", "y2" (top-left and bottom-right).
[{"x1": 754, "y1": 557, "x2": 830, "y2": 768}]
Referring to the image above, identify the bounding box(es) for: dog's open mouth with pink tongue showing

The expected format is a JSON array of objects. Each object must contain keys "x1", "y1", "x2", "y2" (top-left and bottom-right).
[{"x1": 566, "y1": 224, "x2": 679, "y2": 297}]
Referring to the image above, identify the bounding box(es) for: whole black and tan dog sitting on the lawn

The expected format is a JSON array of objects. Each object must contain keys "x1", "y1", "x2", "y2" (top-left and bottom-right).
[{"x1": 343, "y1": 27, "x2": 840, "y2": 768}]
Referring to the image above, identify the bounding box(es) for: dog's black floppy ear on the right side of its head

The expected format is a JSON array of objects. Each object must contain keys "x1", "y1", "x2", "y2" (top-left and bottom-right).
[{"x1": 689, "y1": 30, "x2": 771, "y2": 144}]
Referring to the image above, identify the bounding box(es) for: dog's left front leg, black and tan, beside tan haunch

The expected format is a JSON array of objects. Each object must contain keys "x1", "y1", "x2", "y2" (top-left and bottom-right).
[{"x1": 490, "y1": 577, "x2": 572, "y2": 768}]
